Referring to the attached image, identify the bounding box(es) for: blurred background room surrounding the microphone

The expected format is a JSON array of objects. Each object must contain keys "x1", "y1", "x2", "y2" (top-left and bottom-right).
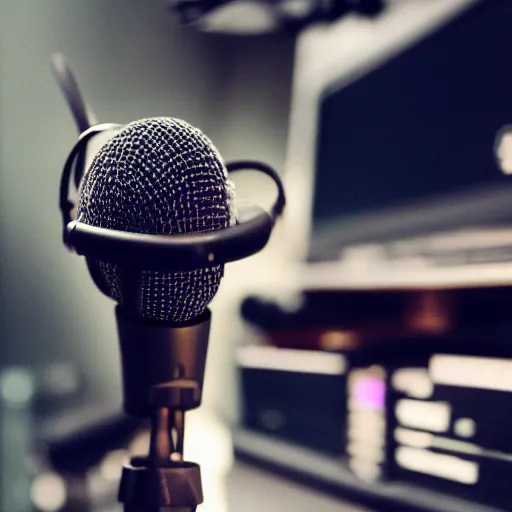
[{"x1": 0, "y1": 0, "x2": 512, "y2": 512}]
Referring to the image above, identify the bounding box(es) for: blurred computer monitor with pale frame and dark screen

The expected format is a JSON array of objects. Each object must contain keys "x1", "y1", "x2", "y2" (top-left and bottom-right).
[{"x1": 286, "y1": 0, "x2": 512, "y2": 274}]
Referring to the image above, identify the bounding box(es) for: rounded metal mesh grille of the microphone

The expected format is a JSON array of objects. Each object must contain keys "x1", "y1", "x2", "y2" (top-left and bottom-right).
[{"x1": 77, "y1": 118, "x2": 234, "y2": 322}]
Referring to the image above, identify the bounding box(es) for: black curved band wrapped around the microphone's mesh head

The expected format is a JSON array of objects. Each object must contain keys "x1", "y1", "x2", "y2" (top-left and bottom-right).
[{"x1": 59, "y1": 124, "x2": 286, "y2": 271}]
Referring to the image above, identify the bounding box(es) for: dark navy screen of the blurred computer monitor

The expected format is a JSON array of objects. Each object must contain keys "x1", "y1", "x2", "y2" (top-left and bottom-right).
[{"x1": 312, "y1": 0, "x2": 512, "y2": 252}]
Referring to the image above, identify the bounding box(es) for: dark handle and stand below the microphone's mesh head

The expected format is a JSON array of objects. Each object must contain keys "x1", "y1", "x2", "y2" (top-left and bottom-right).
[{"x1": 116, "y1": 306, "x2": 211, "y2": 512}]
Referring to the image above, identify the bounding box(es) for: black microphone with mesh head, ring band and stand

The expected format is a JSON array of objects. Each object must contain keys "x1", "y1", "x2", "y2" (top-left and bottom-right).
[{"x1": 60, "y1": 117, "x2": 285, "y2": 512}]
